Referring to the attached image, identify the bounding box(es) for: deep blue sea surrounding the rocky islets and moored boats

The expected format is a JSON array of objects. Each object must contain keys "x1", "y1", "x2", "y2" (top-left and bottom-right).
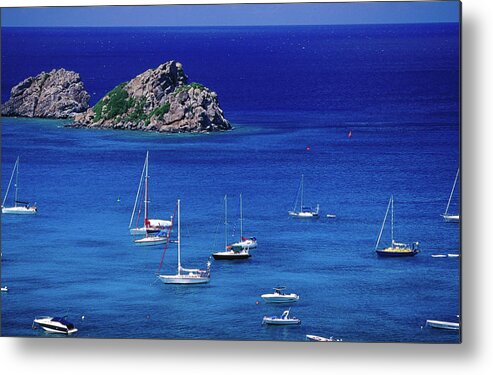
[{"x1": 1, "y1": 24, "x2": 460, "y2": 342}]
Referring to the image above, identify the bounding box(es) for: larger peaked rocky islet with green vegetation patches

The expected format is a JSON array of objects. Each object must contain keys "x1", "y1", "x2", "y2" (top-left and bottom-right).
[{"x1": 73, "y1": 61, "x2": 231, "y2": 133}]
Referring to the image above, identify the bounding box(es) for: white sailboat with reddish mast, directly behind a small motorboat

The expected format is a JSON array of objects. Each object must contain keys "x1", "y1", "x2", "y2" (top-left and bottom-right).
[{"x1": 128, "y1": 151, "x2": 171, "y2": 236}]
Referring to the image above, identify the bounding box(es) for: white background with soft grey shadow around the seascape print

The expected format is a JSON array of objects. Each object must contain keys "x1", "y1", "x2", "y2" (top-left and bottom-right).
[{"x1": 0, "y1": 0, "x2": 493, "y2": 375}]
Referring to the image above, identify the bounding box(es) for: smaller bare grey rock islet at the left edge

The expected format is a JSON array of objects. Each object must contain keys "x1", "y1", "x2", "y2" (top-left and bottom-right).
[{"x1": 2, "y1": 69, "x2": 89, "y2": 118}]
